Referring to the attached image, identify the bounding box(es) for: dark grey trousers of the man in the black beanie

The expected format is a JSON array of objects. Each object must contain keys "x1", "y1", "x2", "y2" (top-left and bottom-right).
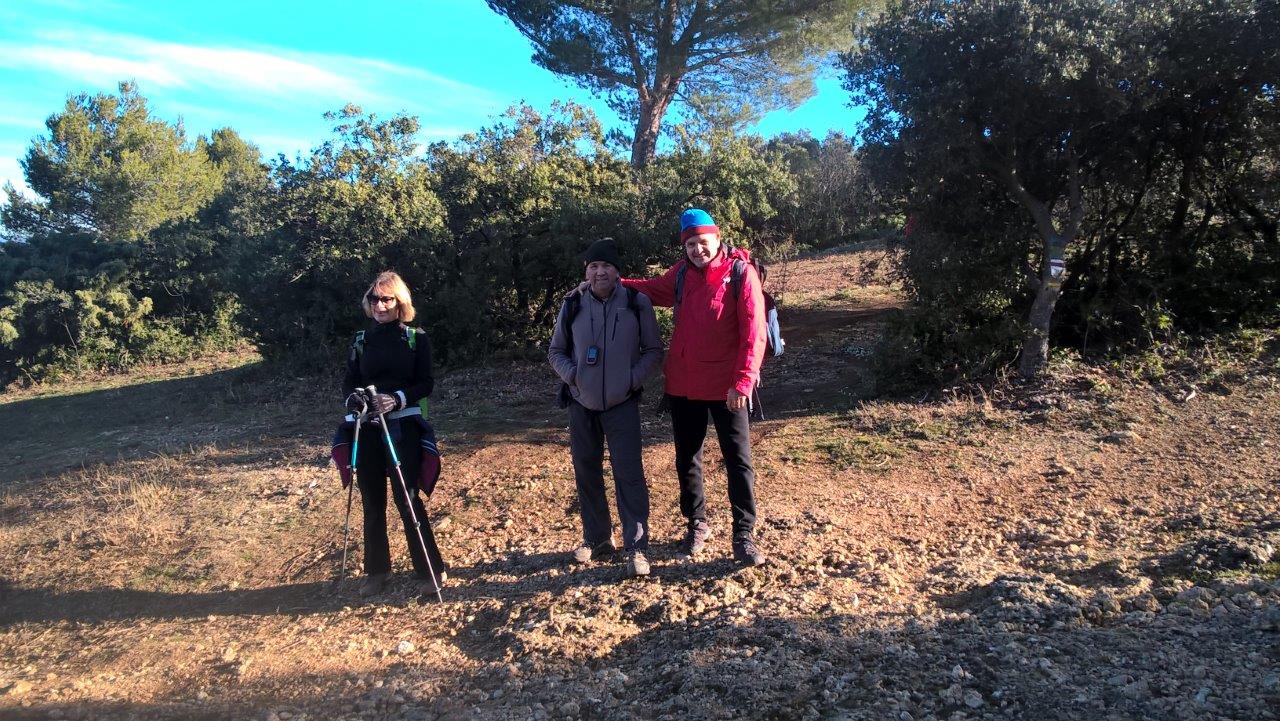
[{"x1": 568, "y1": 398, "x2": 649, "y2": 551}]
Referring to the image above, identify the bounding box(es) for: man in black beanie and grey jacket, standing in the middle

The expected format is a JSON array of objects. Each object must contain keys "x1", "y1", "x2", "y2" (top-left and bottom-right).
[{"x1": 547, "y1": 238, "x2": 662, "y2": 576}]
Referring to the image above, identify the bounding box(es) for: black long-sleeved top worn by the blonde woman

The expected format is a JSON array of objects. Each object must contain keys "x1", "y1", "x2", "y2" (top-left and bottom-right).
[{"x1": 342, "y1": 321, "x2": 435, "y2": 407}]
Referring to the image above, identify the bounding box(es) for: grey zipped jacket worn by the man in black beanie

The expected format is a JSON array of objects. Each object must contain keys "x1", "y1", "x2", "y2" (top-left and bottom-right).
[{"x1": 547, "y1": 283, "x2": 662, "y2": 411}]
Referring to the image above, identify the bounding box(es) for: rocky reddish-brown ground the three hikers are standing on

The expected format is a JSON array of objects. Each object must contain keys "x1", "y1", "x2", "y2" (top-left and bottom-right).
[{"x1": 0, "y1": 248, "x2": 1280, "y2": 721}]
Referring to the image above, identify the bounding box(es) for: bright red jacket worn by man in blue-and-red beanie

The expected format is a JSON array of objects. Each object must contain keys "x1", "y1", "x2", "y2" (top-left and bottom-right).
[{"x1": 622, "y1": 248, "x2": 767, "y2": 401}]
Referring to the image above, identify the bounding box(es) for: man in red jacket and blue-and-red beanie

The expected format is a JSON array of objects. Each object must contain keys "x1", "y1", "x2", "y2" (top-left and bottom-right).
[{"x1": 622, "y1": 209, "x2": 765, "y2": 566}]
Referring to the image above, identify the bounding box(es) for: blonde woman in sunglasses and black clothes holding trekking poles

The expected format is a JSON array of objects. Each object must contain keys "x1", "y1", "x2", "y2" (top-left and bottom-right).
[{"x1": 334, "y1": 271, "x2": 444, "y2": 597}]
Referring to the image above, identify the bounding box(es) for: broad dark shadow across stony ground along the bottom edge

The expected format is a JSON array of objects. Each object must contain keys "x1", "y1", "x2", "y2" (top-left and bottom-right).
[{"x1": 6, "y1": 581, "x2": 1280, "y2": 721}]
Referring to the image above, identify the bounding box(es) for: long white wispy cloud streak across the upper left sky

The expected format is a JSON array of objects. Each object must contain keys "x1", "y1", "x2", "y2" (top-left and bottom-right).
[{"x1": 0, "y1": 31, "x2": 497, "y2": 109}]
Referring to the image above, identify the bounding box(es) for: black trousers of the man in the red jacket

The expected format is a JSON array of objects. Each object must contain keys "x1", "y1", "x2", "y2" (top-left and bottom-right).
[{"x1": 671, "y1": 396, "x2": 755, "y2": 538}]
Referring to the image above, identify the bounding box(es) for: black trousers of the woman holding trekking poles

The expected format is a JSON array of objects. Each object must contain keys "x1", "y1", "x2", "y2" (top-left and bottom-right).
[{"x1": 356, "y1": 420, "x2": 444, "y2": 581}]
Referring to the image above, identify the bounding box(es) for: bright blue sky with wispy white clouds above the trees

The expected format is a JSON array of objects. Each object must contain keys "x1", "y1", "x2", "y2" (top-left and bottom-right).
[{"x1": 0, "y1": 0, "x2": 860, "y2": 194}]
